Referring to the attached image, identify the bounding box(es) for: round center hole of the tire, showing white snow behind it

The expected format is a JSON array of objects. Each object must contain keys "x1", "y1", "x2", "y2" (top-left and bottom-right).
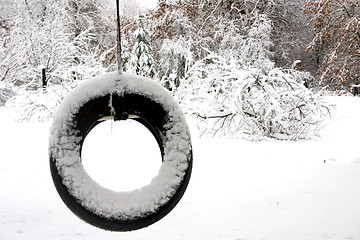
[{"x1": 81, "y1": 120, "x2": 162, "y2": 191}]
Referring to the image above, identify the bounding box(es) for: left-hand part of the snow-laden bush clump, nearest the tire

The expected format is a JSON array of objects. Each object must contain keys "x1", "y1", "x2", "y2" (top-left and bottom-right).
[{"x1": 173, "y1": 53, "x2": 236, "y2": 118}]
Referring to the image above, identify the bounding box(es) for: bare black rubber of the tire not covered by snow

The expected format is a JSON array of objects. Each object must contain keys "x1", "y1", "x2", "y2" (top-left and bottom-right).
[{"x1": 50, "y1": 86, "x2": 192, "y2": 231}]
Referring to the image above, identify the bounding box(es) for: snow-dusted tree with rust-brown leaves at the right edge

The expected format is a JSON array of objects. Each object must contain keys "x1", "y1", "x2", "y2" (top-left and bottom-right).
[{"x1": 306, "y1": 0, "x2": 360, "y2": 90}]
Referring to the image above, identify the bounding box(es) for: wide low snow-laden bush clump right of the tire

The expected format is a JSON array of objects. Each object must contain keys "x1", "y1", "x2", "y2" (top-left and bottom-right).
[{"x1": 177, "y1": 56, "x2": 332, "y2": 140}]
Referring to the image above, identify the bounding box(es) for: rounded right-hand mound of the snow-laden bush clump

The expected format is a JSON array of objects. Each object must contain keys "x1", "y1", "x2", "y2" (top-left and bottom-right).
[{"x1": 233, "y1": 68, "x2": 331, "y2": 140}]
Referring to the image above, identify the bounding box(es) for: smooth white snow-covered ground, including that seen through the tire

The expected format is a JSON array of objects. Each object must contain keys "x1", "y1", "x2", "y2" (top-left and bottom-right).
[{"x1": 0, "y1": 97, "x2": 360, "y2": 240}]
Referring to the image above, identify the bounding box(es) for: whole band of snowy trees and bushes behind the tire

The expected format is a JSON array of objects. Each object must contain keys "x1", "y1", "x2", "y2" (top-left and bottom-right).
[{"x1": 0, "y1": 0, "x2": 360, "y2": 138}]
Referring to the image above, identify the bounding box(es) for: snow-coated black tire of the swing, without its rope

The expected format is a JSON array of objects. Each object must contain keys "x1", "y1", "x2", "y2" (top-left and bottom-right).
[{"x1": 49, "y1": 73, "x2": 192, "y2": 231}]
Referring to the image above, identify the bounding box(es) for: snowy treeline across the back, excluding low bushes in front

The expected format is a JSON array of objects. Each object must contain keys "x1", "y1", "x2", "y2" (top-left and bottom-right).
[{"x1": 0, "y1": 0, "x2": 360, "y2": 90}]
